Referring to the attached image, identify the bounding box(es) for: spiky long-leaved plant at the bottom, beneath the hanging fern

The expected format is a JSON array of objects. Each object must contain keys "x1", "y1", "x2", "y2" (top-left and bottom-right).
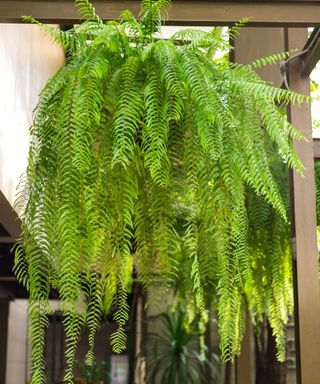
[{"x1": 146, "y1": 308, "x2": 221, "y2": 384}]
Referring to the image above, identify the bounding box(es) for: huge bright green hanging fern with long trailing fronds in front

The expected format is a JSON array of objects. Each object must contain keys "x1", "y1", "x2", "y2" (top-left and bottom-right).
[{"x1": 15, "y1": 0, "x2": 304, "y2": 383}]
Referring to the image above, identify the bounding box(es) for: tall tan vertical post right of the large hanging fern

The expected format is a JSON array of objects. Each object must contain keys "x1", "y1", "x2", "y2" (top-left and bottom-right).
[{"x1": 286, "y1": 28, "x2": 320, "y2": 384}]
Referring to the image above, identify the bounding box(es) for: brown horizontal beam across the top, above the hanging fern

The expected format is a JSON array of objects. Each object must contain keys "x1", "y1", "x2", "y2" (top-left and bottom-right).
[{"x1": 0, "y1": 0, "x2": 320, "y2": 27}]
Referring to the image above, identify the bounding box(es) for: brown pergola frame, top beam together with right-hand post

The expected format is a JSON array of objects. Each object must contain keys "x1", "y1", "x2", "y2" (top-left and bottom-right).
[{"x1": 0, "y1": 0, "x2": 320, "y2": 384}]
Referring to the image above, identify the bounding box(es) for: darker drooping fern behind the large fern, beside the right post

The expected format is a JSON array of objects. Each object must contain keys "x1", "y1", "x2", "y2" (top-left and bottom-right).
[{"x1": 245, "y1": 145, "x2": 293, "y2": 361}]
